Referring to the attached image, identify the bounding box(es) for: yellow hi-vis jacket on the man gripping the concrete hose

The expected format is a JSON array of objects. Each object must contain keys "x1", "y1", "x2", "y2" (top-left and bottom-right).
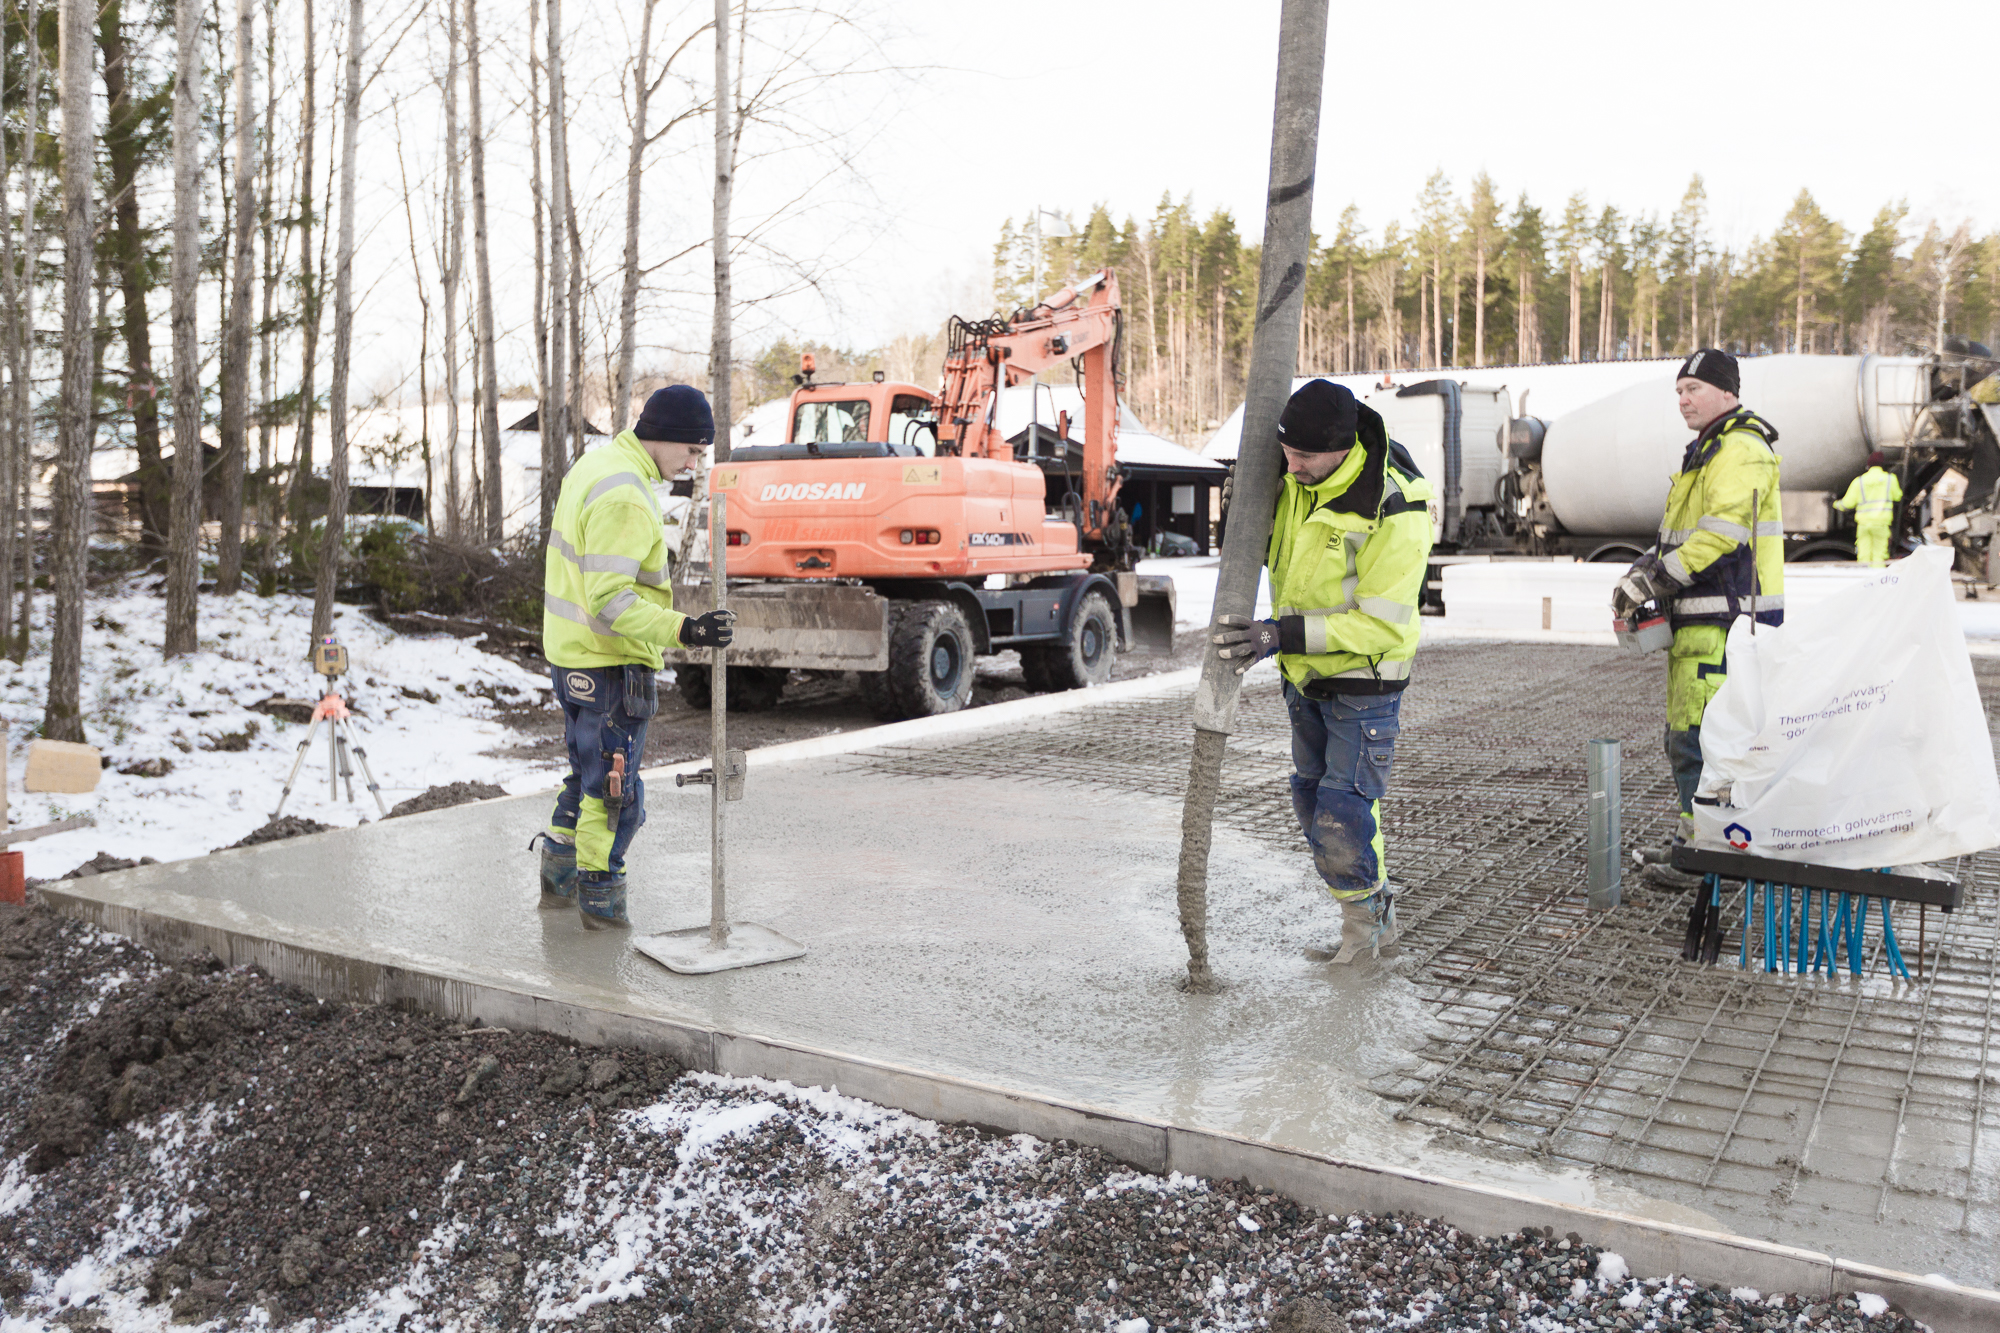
[{"x1": 1264, "y1": 404, "x2": 1432, "y2": 697}]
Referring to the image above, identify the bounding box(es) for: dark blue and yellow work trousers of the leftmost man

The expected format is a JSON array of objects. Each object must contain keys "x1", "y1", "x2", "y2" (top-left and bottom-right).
[{"x1": 548, "y1": 667, "x2": 660, "y2": 877}]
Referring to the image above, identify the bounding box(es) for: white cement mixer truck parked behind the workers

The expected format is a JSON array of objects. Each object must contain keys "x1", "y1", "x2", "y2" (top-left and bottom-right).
[{"x1": 1256, "y1": 340, "x2": 2000, "y2": 592}]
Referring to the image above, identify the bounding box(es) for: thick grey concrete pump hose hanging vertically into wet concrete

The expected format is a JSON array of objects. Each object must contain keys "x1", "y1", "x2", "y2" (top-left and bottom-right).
[{"x1": 1178, "y1": 0, "x2": 1326, "y2": 991}]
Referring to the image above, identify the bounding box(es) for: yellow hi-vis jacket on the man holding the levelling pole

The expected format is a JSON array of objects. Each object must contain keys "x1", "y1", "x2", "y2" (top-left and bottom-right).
[{"x1": 542, "y1": 430, "x2": 686, "y2": 669}]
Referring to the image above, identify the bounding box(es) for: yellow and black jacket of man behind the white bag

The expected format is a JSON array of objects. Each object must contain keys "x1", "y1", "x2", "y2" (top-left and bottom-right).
[{"x1": 1660, "y1": 408, "x2": 1784, "y2": 628}]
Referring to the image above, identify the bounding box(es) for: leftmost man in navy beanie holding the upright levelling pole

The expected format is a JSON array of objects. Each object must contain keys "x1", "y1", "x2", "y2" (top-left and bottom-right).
[{"x1": 530, "y1": 384, "x2": 736, "y2": 931}]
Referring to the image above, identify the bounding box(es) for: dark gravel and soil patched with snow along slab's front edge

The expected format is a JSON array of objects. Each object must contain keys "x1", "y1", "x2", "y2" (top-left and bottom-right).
[{"x1": 0, "y1": 907, "x2": 1920, "y2": 1333}]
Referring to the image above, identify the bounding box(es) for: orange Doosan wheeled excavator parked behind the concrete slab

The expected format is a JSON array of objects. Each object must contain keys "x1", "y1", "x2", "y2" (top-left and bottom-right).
[{"x1": 668, "y1": 272, "x2": 1174, "y2": 719}]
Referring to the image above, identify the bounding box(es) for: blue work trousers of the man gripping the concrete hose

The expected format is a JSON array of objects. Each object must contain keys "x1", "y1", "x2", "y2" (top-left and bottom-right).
[{"x1": 1284, "y1": 681, "x2": 1402, "y2": 899}]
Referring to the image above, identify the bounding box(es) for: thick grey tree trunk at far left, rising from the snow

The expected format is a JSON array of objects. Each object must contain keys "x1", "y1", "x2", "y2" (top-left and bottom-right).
[{"x1": 42, "y1": 0, "x2": 96, "y2": 741}]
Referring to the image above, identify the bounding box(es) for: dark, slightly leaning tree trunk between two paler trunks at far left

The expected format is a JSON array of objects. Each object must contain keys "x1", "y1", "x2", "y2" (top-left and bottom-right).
[{"x1": 98, "y1": 0, "x2": 168, "y2": 560}]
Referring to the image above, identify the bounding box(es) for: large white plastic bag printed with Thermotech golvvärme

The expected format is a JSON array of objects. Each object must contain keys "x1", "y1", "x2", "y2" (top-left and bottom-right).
[{"x1": 1694, "y1": 546, "x2": 2000, "y2": 871}]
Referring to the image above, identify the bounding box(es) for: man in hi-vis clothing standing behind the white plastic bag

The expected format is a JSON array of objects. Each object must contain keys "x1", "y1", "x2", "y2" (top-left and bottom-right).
[{"x1": 1612, "y1": 346, "x2": 1784, "y2": 889}]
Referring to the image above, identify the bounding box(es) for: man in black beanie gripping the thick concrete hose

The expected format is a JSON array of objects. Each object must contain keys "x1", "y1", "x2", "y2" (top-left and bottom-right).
[{"x1": 1214, "y1": 380, "x2": 1432, "y2": 963}]
